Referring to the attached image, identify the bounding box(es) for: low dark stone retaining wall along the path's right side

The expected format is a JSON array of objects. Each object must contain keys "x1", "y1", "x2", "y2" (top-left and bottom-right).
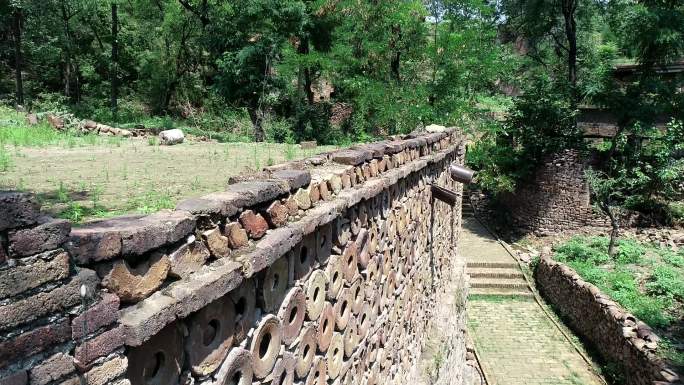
[{"x1": 536, "y1": 255, "x2": 681, "y2": 385}]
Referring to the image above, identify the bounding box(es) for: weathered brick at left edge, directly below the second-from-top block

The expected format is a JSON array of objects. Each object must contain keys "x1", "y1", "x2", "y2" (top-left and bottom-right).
[{"x1": 0, "y1": 250, "x2": 69, "y2": 299}]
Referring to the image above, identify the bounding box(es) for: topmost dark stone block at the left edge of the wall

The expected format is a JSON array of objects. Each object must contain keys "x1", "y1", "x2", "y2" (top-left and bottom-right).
[{"x1": 0, "y1": 191, "x2": 40, "y2": 231}]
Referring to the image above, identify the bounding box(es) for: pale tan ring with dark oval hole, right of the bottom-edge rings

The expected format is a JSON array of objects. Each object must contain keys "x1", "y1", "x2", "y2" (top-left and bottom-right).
[{"x1": 249, "y1": 314, "x2": 281, "y2": 379}]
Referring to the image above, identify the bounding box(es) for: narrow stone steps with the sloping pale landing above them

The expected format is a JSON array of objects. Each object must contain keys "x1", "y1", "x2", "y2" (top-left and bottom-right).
[{"x1": 461, "y1": 199, "x2": 532, "y2": 297}]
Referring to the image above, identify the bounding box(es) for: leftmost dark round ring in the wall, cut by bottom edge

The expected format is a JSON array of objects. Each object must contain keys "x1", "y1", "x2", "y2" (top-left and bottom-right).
[{"x1": 127, "y1": 322, "x2": 184, "y2": 385}]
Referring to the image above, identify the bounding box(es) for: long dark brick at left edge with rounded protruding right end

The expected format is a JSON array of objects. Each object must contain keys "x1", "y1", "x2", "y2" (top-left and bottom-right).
[{"x1": 0, "y1": 269, "x2": 99, "y2": 330}]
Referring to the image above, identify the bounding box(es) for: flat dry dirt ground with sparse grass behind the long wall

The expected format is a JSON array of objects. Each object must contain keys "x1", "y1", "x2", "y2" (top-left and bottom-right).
[{"x1": 0, "y1": 138, "x2": 333, "y2": 221}]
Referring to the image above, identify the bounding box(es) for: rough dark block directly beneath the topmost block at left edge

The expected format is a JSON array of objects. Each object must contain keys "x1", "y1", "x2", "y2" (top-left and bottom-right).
[{"x1": 8, "y1": 218, "x2": 71, "y2": 258}]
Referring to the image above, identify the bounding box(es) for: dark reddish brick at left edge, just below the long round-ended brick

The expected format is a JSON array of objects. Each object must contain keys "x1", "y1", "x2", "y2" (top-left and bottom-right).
[{"x1": 0, "y1": 319, "x2": 71, "y2": 368}]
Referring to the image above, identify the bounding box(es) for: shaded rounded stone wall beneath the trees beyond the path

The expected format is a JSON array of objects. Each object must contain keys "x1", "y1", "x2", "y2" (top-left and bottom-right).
[{"x1": 501, "y1": 150, "x2": 610, "y2": 235}]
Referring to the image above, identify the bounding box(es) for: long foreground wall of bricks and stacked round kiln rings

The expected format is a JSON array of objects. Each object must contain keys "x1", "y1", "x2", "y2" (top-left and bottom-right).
[{"x1": 0, "y1": 131, "x2": 466, "y2": 385}]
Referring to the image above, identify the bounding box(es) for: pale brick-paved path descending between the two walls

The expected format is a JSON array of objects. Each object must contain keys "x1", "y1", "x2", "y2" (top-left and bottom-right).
[{"x1": 461, "y1": 218, "x2": 604, "y2": 385}]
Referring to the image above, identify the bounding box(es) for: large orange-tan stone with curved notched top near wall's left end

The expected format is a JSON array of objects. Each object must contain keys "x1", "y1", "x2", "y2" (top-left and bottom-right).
[{"x1": 101, "y1": 253, "x2": 171, "y2": 303}]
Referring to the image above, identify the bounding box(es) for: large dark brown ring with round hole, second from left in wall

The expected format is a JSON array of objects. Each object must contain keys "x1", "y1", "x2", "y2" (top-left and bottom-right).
[{"x1": 185, "y1": 295, "x2": 235, "y2": 376}]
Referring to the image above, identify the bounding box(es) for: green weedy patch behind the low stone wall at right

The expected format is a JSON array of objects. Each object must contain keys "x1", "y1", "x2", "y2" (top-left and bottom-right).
[{"x1": 554, "y1": 237, "x2": 684, "y2": 367}]
